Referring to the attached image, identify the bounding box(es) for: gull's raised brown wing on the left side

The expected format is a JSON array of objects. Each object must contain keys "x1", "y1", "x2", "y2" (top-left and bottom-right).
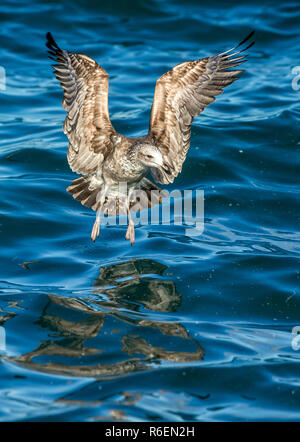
[{"x1": 46, "y1": 32, "x2": 116, "y2": 175}]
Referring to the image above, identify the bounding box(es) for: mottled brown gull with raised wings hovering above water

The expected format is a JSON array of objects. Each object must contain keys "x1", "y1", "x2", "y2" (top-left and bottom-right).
[{"x1": 46, "y1": 31, "x2": 254, "y2": 245}]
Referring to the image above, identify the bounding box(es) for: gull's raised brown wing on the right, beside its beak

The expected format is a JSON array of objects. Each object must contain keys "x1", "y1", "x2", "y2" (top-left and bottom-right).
[{"x1": 148, "y1": 31, "x2": 254, "y2": 184}]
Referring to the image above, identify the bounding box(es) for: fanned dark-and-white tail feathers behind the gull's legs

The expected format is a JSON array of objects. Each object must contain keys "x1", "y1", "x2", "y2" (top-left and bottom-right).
[{"x1": 66, "y1": 177, "x2": 166, "y2": 215}]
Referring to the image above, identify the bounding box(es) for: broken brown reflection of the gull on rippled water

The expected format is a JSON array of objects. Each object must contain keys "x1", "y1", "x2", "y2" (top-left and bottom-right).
[{"x1": 6, "y1": 259, "x2": 204, "y2": 378}]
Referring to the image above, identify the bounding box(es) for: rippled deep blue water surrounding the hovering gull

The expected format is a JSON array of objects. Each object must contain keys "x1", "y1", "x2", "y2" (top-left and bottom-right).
[{"x1": 0, "y1": 0, "x2": 300, "y2": 421}]
